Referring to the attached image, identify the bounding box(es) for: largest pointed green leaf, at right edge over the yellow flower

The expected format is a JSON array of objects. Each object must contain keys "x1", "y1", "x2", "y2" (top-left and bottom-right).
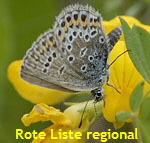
[{"x1": 120, "y1": 18, "x2": 150, "y2": 83}]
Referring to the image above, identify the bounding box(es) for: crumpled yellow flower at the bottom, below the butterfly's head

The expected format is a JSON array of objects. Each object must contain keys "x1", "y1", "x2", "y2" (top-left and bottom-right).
[{"x1": 22, "y1": 101, "x2": 102, "y2": 143}]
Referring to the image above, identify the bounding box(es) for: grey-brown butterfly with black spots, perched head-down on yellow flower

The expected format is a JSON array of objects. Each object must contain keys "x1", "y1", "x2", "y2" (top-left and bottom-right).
[{"x1": 21, "y1": 4, "x2": 122, "y2": 103}]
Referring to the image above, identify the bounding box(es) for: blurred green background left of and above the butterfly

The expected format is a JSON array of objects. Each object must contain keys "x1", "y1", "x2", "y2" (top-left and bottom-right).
[{"x1": 0, "y1": 0, "x2": 150, "y2": 143}]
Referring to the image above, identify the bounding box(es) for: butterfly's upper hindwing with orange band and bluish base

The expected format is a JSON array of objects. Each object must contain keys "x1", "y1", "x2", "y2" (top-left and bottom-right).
[{"x1": 54, "y1": 5, "x2": 108, "y2": 90}]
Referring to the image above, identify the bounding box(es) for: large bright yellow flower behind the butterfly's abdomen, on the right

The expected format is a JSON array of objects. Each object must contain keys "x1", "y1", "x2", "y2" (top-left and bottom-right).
[{"x1": 103, "y1": 16, "x2": 150, "y2": 128}]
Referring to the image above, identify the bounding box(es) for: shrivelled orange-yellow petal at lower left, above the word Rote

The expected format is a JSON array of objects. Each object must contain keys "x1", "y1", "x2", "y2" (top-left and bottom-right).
[{"x1": 21, "y1": 103, "x2": 71, "y2": 126}]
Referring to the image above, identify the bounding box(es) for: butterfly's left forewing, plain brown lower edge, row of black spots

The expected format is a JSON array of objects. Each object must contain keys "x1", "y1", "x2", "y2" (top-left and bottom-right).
[{"x1": 20, "y1": 30, "x2": 84, "y2": 92}]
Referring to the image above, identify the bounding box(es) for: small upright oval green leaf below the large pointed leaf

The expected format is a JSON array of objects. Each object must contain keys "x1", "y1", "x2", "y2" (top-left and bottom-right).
[{"x1": 130, "y1": 82, "x2": 143, "y2": 112}]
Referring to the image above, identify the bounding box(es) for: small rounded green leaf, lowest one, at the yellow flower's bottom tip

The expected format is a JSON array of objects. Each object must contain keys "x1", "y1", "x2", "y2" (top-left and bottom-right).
[{"x1": 116, "y1": 111, "x2": 132, "y2": 122}]
